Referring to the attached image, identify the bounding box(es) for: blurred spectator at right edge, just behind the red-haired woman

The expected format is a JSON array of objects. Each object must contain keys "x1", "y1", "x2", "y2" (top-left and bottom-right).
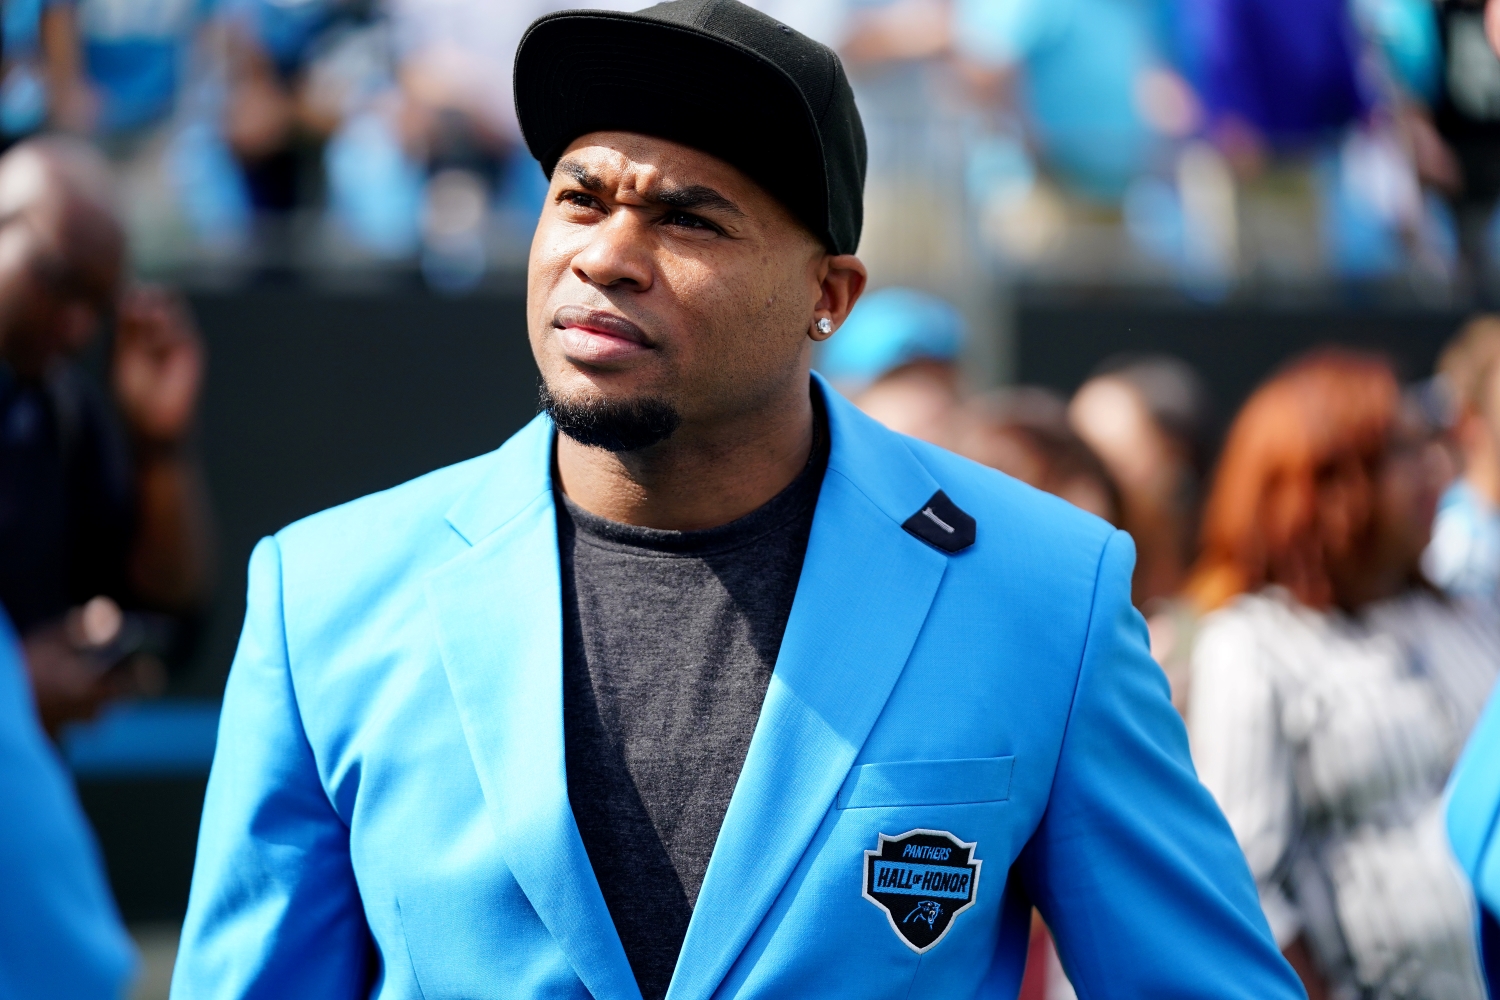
[{"x1": 1422, "y1": 316, "x2": 1500, "y2": 600}]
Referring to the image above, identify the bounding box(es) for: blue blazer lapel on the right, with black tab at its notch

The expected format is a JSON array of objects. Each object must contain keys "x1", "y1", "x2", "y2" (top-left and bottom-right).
[{"x1": 668, "y1": 379, "x2": 947, "y2": 1000}]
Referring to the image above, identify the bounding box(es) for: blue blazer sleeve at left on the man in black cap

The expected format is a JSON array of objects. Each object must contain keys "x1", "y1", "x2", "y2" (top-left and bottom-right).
[{"x1": 173, "y1": 538, "x2": 371, "y2": 1000}]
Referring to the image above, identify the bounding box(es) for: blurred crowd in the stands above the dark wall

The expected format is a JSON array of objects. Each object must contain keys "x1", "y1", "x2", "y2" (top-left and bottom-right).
[{"x1": 0, "y1": 0, "x2": 1500, "y2": 290}]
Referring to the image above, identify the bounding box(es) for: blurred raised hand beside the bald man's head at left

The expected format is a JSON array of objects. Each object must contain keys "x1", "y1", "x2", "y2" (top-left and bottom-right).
[{"x1": 114, "y1": 288, "x2": 204, "y2": 445}]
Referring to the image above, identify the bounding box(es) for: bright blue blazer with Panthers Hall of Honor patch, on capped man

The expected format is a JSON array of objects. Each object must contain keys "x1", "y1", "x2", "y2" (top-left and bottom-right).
[{"x1": 173, "y1": 379, "x2": 1302, "y2": 1000}]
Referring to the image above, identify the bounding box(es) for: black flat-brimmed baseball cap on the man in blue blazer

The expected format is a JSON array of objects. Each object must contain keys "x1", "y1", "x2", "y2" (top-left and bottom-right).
[{"x1": 516, "y1": 0, "x2": 867, "y2": 253}]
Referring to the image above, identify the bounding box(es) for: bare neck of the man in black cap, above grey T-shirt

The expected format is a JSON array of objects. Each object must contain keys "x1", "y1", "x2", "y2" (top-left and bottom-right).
[{"x1": 557, "y1": 382, "x2": 813, "y2": 531}]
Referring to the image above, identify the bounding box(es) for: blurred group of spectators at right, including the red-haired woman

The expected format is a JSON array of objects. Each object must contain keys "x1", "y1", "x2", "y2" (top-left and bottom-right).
[{"x1": 821, "y1": 288, "x2": 1500, "y2": 1000}]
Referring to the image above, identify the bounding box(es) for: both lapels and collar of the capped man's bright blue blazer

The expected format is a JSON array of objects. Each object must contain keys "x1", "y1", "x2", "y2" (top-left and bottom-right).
[{"x1": 428, "y1": 375, "x2": 948, "y2": 1000}]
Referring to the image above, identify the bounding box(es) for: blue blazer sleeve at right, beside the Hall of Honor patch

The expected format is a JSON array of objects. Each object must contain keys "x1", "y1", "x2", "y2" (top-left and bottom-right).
[{"x1": 1017, "y1": 532, "x2": 1305, "y2": 1000}]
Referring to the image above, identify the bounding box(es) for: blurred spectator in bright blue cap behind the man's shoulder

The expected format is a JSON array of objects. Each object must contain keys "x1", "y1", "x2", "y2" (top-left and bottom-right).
[{"x1": 818, "y1": 288, "x2": 965, "y2": 445}]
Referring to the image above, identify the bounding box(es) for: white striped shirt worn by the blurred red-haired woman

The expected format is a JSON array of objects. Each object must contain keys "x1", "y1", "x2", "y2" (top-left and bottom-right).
[{"x1": 1188, "y1": 588, "x2": 1500, "y2": 1000}]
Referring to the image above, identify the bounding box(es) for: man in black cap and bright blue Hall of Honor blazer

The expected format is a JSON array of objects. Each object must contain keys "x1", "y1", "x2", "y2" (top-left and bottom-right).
[{"x1": 174, "y1": 0, "x2": 1302, "y2": 1000}]
